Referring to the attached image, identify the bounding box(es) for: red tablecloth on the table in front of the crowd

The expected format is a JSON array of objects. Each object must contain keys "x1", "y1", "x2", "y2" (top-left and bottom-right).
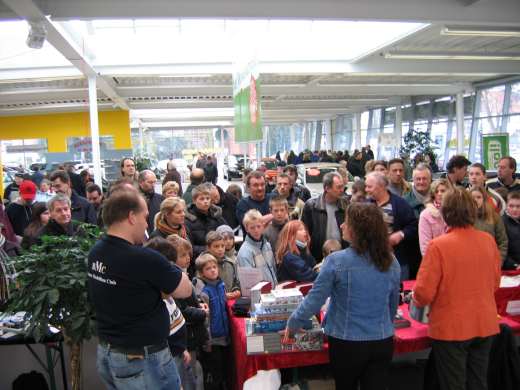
[{"x1": 228, "y1": 274, "x2": 520, "y2": 390}]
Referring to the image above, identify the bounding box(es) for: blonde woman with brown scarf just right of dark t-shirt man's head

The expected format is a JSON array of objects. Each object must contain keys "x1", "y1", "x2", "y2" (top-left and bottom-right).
[{"x1": 150, "y1": 197, "x2": 188, "y2": 239}]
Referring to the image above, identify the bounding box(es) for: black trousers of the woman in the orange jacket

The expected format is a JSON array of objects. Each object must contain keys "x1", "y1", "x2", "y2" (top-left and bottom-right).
[{"x1": 432, "y1": 336, "x2": 495, "y2": 390}]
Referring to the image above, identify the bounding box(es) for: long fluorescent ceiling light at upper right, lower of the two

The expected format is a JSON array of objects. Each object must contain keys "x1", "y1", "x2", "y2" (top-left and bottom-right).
[{"x1": 383, "y1": 51, "x2": 520, "y2": 61}]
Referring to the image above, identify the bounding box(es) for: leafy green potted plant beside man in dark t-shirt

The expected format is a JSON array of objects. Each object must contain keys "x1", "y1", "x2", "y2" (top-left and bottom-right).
[{"x1": 8, "y1": 225, "x2": 100, "y2": 390}]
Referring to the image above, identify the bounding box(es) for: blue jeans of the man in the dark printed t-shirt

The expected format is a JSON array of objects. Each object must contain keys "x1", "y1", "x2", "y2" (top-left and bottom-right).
[{"x1": 97, "y1": 345, "x2": 181, "y2": 390}]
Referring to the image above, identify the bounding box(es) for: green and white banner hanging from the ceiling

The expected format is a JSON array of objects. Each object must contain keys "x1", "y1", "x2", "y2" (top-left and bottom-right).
[{"x1": 233, "y1": 61, "x2": 263, "y2": 142}]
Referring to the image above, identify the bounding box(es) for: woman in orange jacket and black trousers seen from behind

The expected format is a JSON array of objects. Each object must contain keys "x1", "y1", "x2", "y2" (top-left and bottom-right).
[{"x1": 413, "y1": 188, "x2": 501, "y2": 390}]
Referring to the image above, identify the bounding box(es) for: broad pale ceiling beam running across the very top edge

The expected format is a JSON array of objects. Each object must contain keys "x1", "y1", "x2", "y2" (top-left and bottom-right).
[{"x1": 1, "y1": 0, "x2": 520, "y2": 25}]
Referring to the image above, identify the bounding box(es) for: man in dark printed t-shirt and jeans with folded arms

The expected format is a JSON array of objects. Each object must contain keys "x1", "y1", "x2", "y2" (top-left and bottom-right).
[{"x1": 88, "y1": 188, "x2": 192, "y2": 390}]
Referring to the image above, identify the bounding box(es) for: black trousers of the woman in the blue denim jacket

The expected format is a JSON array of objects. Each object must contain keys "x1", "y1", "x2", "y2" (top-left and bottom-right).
[{"x1": 329, "y1": 336, "x2": 394, "y2": 390}]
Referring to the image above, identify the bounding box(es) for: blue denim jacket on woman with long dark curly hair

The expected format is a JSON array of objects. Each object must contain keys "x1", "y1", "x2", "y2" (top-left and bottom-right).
[{"x1": 287, "y1": 248, "x2": 401, "y2": 341}]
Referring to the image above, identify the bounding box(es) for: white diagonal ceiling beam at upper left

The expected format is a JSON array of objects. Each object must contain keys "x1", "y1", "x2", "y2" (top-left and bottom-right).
[{"x1": 3, "y1": 0, "x2": 130, "y2": 110}]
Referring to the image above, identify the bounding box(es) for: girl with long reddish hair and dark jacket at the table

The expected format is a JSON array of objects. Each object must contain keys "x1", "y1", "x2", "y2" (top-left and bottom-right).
[{"x1": 276, "y1": 221, "x2": 318, "y2": 282}]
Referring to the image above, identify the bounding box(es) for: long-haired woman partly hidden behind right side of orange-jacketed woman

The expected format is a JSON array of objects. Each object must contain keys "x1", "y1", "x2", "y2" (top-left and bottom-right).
[{"x1": 469, "y1": 187, "x2": 508, "y2": 262}]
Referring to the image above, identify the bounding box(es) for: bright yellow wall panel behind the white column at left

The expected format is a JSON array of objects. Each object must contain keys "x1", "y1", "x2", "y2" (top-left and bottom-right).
[{"x1": 0, "y1": 110, "x2": 132, "y2": 153}]
